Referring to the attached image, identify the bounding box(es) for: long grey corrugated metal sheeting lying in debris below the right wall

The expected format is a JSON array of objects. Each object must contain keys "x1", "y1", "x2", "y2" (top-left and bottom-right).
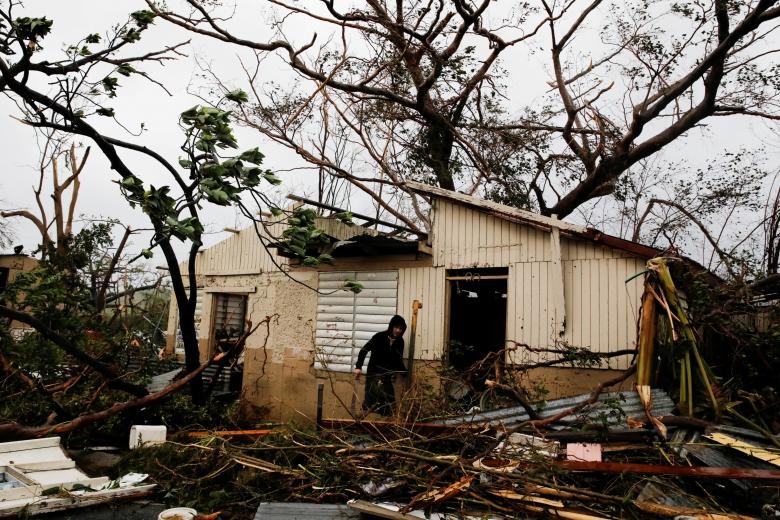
[{"x1": 441, "y1": 388, "x2": 674, "y2": 427}]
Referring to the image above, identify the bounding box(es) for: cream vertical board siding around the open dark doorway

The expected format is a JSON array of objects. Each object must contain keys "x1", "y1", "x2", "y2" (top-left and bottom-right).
[{"x1": 426, "y1": 199, "x2": 645, "y2": 368}]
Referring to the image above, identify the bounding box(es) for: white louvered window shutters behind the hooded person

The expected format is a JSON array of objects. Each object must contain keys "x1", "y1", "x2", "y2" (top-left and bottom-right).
[{"x1": 315, "y1": 271, "x2": 398, "y2": 372}]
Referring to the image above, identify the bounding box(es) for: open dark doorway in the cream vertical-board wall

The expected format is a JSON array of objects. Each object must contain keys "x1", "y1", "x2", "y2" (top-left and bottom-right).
[{"x1": 447, "y1": 268, "x2": 508, "y2": 370}]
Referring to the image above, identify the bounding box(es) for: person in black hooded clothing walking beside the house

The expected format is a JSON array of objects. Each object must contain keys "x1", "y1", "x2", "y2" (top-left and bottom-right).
[{"x1": 355, "y1": 314, "x2": 406, "y2": 415}]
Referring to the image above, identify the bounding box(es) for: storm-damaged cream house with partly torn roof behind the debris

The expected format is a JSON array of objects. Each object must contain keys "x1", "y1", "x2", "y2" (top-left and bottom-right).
[{"x1": 168, "y1": 183, "x2": 659, "y2": 420}]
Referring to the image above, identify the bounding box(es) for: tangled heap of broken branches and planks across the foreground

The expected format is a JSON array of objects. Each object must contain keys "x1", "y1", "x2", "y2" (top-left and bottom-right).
[{"x1": 120, "y1": 410, "x2": 780, "y2": 519}]
